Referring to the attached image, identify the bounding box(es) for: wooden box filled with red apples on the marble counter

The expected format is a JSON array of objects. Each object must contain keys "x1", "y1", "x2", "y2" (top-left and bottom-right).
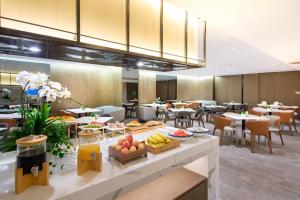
[{"x1": 108, "y1": 134, "x2": 147, "y2": 164}]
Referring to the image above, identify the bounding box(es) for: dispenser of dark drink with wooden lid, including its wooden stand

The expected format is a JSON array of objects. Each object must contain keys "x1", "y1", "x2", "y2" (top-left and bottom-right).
[{"x1": 15, "y1": 135, "x2": 49, "y2": 194}]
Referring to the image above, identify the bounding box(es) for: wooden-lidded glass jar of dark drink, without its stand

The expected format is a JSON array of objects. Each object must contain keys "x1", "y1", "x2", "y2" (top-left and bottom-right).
[{"x1": 16, "y1": 135, "x2": 47, "y2": 176}]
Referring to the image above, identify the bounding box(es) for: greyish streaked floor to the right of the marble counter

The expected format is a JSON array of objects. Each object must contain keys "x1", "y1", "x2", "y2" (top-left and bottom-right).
[{"x1": 127, "y1": 117, "x2": 300, "y2": 200}]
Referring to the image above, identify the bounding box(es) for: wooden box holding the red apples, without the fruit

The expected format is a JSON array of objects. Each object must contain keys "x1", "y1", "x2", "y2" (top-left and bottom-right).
[{"x1": 108, "y1": 146, "x2": 147, "y2": 164}]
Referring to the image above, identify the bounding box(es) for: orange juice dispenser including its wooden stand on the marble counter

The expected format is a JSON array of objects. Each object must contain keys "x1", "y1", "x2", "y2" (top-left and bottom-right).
[{"x1": 77, "y1": 130, "x2": 102, "y2": 175}]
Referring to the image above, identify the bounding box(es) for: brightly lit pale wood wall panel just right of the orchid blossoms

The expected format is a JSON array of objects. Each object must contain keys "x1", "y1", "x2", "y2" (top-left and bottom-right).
[{"x1": 50, "y1": 63, "x2": 122, "y2": 112}]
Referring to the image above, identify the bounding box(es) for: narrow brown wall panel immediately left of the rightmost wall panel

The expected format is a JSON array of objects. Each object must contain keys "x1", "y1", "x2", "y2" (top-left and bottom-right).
[{"x1": 244, "y1": 74, "x2": 259, "y2": 107}]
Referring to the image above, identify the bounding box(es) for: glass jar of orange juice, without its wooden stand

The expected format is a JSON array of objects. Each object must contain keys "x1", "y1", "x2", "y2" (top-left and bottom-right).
[{"x1": 78, "y1": 130, "x2": 101, "y2": 161}]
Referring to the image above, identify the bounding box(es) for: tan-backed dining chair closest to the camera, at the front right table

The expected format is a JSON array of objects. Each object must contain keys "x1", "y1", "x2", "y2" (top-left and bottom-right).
[{"x1": 246, "y1": 120, "x2": 272, "y2": 154}]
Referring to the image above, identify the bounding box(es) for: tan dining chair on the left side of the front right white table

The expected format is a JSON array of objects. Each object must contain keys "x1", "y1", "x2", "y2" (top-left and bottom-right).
[{"x1": 213, "y1": 115, "x2": 236, "y2": 144}]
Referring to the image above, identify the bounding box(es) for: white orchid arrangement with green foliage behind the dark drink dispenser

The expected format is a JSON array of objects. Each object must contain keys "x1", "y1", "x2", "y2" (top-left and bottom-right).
[{"x1": 0, "y1": 71, "x2": 82, "y2": 173}]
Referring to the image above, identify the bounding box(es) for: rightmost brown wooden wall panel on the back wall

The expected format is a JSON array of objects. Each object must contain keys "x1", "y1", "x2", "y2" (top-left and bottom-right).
[{"x1": 259, "y1": 71, "x2": 300, "y2": 106}]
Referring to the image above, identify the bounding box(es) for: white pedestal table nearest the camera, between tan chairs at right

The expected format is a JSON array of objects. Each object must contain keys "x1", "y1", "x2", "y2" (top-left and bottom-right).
[{"x1": 223, "y1": 112, "x2": 269, "y2": 145}]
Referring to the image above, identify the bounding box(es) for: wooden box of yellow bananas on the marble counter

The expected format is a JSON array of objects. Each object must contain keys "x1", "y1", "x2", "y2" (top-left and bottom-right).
[{"x1": 145, "y1": 133, "x2": 180, "y2": 154}]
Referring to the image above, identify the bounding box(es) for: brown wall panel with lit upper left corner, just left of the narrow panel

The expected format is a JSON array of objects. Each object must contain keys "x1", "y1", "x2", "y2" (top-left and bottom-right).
[{"x1": 215, "y1": 75, "x2": 242, "y2": 103}]
